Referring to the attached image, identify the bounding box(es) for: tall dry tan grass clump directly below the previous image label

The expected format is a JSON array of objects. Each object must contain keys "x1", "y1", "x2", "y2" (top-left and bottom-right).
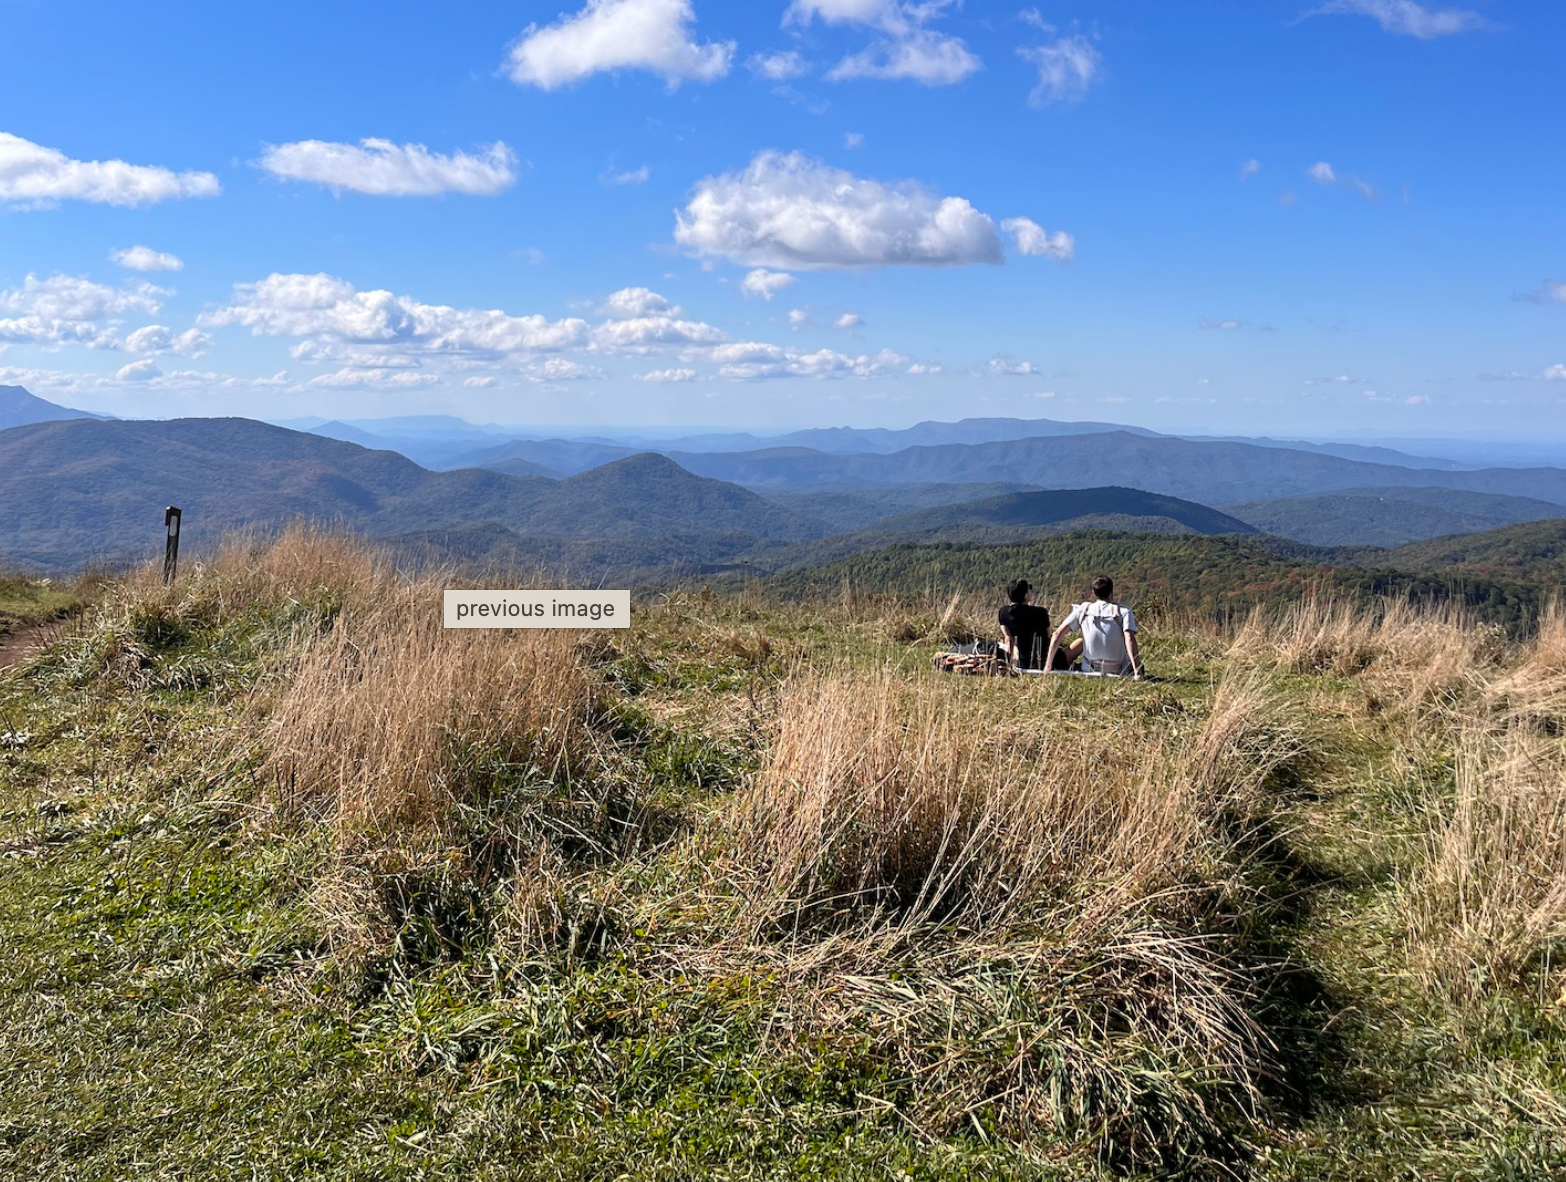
[{"x1": 268, "y1": 584, "x2": 592, "y2": 833}]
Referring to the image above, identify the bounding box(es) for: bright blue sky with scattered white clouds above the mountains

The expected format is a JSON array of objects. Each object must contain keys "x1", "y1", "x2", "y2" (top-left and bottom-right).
[{"x1": 0, "y1": 0, "x2": 1566, "y2": 438}]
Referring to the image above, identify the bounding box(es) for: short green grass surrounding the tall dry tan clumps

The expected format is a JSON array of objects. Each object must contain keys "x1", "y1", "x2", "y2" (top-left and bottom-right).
[{"x1": 0, "y1": 569, "x2": 1566, "y2": 1182}]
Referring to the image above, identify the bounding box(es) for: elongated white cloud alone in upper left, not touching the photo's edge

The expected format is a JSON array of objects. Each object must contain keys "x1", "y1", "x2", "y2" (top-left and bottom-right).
[{"x1": 260, "y1": 139, "x2": 517, "y2": 197}]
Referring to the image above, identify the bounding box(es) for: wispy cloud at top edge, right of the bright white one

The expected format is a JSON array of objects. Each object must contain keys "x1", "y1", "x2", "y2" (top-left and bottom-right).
[{"x1": 783, "y1": 0, "x2": 982, "y2": 86}]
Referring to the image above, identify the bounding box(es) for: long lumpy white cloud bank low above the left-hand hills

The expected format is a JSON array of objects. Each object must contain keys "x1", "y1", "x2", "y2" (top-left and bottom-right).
[{"x1": 199, "y1": 274, "x2": 589, "y2": 357}]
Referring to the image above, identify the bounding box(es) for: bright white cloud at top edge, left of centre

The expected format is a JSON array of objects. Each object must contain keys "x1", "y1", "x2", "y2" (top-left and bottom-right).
[{"x1": 507, "y1": 0, "x2": 734, "y2": 91}]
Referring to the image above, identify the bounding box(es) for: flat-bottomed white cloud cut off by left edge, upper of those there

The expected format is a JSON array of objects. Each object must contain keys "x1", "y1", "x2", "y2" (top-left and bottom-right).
[{"x1": 0, "y1": 132, "x2": 221, "y2": 208}]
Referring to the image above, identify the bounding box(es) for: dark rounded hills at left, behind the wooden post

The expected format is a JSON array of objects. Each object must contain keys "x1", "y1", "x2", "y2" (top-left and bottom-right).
[{"x1": 0, "y1": 418, "x2": 821, "y2": 570}]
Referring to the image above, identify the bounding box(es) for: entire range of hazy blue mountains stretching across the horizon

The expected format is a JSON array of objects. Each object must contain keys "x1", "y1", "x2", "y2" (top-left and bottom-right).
[{"x1": 9, "y1": 387, "x2": 1566, "y2": 576}]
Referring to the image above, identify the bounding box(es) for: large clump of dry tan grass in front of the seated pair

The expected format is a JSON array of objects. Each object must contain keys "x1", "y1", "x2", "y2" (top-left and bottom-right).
[{"x1": 730, "y1": 670, "x2": 1294, "y2": 927}]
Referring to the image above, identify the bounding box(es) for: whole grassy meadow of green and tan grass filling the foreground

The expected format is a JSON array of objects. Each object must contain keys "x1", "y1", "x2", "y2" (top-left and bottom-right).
[{"x1": 0, "y1": 529, "x2": 1566, "y2": 1182}]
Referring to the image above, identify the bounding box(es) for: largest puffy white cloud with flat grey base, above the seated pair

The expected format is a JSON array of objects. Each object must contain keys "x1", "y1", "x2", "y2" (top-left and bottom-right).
[{"x1": 675, "y1": 152, "x2": 1004, "y2": 271}]
